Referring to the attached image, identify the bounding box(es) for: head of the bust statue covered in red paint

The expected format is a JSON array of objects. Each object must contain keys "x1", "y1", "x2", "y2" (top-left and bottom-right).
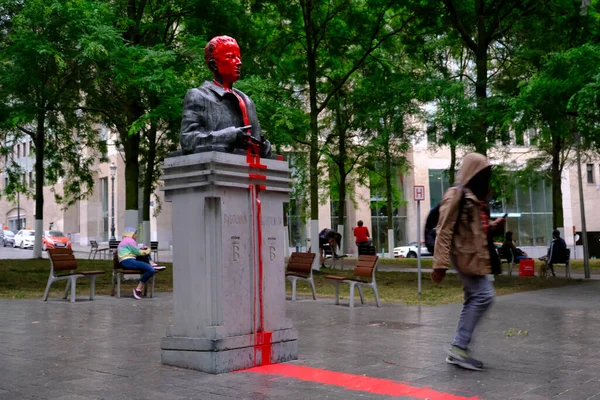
[{"x1": 204, "y1": 36, "x2": 242, "y2": 89}]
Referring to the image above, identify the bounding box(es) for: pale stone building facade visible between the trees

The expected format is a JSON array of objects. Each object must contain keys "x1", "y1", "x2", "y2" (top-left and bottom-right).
[{"x1": 0, "y1": 130, "x2": 600, "y2": 257}]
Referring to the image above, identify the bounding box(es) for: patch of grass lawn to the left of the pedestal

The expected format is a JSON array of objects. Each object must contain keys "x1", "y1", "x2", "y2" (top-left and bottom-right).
[{"x1": 0, "y1": 259, "x2": 173, "y2": 299}]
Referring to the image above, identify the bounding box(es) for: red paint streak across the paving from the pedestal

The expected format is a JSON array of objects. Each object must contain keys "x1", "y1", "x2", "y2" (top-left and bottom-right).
[{"x1": 239, "y1": 364, "x2": 479, "y2": 400}]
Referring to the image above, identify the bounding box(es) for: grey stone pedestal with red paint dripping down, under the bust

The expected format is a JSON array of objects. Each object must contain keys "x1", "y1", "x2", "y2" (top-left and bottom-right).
[{"x1": 161, "y1": 152, "x2": 298, "y2": 374}]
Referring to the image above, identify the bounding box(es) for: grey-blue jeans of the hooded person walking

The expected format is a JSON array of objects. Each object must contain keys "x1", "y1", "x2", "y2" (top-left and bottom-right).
[{"x1": 452, "y1": 271, "x2": 495, "y2": 350}]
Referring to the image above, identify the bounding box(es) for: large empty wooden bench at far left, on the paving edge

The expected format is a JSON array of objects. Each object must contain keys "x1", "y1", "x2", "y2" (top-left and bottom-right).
[{"x1": 42, "y1": 248, "x2": 105, "y2": 303}]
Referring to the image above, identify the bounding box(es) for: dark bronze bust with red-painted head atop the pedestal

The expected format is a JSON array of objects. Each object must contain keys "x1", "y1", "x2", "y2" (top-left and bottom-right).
[{"x1": 180, "y1": 36, "x2": 271, "y2": 157}]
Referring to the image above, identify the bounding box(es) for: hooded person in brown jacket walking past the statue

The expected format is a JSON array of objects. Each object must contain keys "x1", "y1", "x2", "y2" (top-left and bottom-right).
[{"x1": 431, "y1": 153, "x2": 504, "y2": 371}]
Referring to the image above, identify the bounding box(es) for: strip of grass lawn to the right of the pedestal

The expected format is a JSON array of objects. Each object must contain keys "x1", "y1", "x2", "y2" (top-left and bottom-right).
[{"x1": 287, "y1": 268, "x2": 583, "y2": 306}]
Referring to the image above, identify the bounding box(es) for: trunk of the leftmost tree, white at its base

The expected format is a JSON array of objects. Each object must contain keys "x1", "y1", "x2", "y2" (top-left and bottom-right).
[{"x1": 33, "y1": 110, "x2": 46, "y2": 258}]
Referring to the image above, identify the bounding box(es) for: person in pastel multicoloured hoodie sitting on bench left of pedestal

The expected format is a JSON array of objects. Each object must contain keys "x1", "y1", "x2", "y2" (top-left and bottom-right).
[{"x1": 117, "y1": 227, "x2": 165, "y2": 300}]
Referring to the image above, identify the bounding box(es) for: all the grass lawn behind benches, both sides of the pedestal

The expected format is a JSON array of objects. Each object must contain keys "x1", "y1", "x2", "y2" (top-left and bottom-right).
[{"x1": 0, "y1": 260, "x2": 582, "y2": 305}]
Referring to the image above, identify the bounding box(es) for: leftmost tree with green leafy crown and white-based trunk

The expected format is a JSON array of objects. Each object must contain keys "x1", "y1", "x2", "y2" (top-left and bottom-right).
[{"x1": 0, "y1": 0, "x2": 115, "y2": 257}]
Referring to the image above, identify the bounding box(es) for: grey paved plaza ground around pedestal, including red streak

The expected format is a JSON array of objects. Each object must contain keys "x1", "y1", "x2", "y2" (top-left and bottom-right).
[{"x1": 0, "y1": 281, "x2": 600, "y2": 400}]
